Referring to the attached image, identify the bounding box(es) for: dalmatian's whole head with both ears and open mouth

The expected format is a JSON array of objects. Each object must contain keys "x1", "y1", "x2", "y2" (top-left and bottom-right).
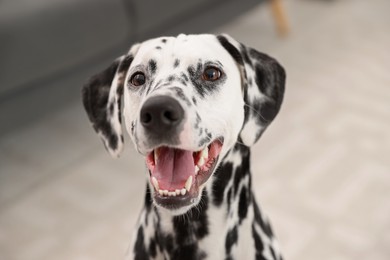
[{"x1": 83, "y1": 35, "x2": 285, "y2": 214}]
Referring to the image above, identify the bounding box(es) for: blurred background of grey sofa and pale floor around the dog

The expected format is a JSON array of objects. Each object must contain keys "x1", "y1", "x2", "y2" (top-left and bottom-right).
[{"x1": 0, "y1": 0, "x2": 390, "y2": 260}]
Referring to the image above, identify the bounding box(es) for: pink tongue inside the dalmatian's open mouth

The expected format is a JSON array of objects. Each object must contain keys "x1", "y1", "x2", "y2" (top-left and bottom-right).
[{"x1": 152, "y1": 147, "x2": 195, "y2": 191}]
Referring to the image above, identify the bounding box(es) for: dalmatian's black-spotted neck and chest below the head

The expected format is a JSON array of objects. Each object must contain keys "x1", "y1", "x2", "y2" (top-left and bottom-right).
[{"x1": 126, "y1": 144, "x2": 282, "y2": 260}]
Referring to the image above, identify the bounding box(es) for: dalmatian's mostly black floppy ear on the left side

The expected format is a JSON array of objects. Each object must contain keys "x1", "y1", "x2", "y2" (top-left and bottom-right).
[{"x1": 82, "y1": 45, "x2": 139, "y2": 157}]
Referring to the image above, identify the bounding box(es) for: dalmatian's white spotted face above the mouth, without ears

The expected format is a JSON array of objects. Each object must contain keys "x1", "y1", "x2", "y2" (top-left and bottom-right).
[{"x1": 124, "y1": 35, "x2": 244, "y2": 156}]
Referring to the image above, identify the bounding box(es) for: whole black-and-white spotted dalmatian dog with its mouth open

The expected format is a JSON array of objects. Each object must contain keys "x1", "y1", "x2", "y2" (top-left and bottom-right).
[{"x1": 83, "y1": 34, "x2": 285, "y2": 260}]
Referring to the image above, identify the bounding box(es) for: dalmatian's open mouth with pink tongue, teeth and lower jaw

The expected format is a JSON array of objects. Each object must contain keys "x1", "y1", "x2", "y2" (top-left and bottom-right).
[{"x1": 146, "y1": 140, "x2": 222, "y2": 209}]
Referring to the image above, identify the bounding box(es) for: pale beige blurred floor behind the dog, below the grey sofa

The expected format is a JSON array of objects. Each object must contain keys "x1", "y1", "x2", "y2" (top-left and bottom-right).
[{"x1": 0, "y1": 0, "x2": 390, "y2": 260}]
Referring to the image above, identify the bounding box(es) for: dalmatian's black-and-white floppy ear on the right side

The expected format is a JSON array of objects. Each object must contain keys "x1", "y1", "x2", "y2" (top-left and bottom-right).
[{"x1": 217, "y1": 34, "x2": 286, "y2": 146}]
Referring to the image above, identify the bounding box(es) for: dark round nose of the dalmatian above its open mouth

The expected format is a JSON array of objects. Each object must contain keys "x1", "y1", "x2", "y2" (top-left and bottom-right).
[{"x1": 140, "y1": 96, "x2": 184, "y2": 132}]
